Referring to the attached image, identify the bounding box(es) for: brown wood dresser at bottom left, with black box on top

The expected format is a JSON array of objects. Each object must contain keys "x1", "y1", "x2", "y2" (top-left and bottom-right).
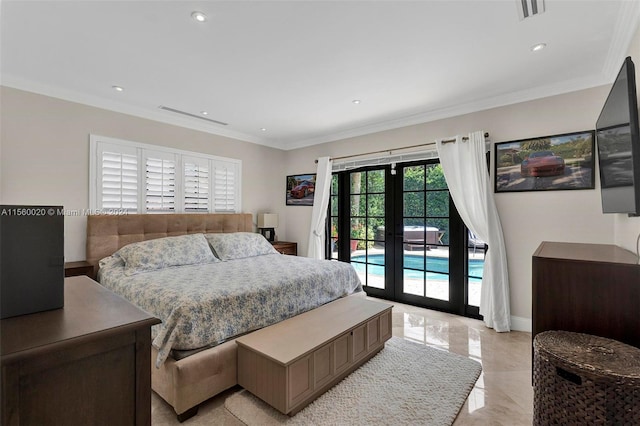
[{"x1": 0, "y1": 276, "x2": 160, "y2": 426}]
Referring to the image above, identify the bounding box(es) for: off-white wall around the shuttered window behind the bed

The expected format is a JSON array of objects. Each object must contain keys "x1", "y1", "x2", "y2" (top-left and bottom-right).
[{"x1": 0, "y1": 87, "x2": 286, "y2": 261}]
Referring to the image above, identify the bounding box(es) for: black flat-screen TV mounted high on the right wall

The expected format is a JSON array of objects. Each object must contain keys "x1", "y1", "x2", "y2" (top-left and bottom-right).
[{"x1": 596, "y1": 57, "x2": 640, "y2": 215}]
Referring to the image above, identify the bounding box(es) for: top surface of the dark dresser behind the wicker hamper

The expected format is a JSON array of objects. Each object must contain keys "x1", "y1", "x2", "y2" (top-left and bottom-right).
[{"x1": 533, "y1": 241, "x2": 638, "y2": 265}]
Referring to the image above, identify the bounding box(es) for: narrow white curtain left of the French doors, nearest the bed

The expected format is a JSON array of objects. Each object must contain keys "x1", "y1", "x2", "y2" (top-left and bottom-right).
[{"x1": 307, "y1": 157, "x2": 331, "y2": 259}]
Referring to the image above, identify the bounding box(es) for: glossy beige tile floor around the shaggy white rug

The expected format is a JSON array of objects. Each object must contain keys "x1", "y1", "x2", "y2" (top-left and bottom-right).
[{"x1": 151, "y1": 302, "x2": 533, "y2": 426}]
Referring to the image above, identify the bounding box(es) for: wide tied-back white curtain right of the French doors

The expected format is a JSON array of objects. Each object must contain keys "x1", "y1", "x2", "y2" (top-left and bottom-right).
[{"x1": 436, "y1": 132, "x2": 511, "y2": 331}]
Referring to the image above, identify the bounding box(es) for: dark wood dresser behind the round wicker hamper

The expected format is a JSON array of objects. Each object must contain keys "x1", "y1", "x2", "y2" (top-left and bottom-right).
[{"x1": 532, "y1": 242, "x2": 640, "y2": 347}]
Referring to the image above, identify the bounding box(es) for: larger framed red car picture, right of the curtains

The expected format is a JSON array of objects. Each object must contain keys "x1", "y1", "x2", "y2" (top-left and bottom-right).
[{"x1": 494, "y1": 130, "x2": 595, "y2": 192}]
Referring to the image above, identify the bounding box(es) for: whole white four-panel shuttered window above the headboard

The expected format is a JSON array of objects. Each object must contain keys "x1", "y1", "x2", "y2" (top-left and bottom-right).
[{"x1": 89, "y1": 135, "x2": 242, "y2": 213}]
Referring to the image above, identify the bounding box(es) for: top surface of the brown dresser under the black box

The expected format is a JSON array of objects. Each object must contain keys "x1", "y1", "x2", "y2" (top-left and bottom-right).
[{"x1": 0, "y1": 276, "x2": 160, "y2": 363}]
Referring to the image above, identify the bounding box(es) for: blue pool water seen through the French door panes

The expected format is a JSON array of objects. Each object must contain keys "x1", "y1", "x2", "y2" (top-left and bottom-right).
[{"x1": 351, "y1": 253, "x2": 484, "y2": 282}]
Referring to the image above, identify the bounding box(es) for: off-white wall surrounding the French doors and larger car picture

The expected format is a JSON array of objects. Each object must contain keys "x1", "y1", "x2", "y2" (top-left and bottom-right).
[{"x1": 283, "y1": 86, "x2": 614, "y2": 329}]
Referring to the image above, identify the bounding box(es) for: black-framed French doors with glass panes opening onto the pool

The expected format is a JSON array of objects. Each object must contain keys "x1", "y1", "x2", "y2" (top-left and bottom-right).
[{"x1": 327, "y1": 160, "x2": 485, "y2": 317}]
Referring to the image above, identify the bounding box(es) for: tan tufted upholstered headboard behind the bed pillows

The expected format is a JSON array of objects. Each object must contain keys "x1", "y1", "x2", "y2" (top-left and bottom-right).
[{"x1": 87, "y1": 213, "x2": 253, "y2": 271}]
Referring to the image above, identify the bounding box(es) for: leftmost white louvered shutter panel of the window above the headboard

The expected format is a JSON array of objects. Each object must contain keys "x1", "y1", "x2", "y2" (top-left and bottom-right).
[{"x1": 98, "y1": 144, "x2": 138, "y2": 212}]
